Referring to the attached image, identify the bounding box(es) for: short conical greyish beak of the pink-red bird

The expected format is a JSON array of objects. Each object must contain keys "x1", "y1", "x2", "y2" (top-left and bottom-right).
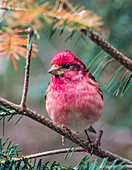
[{"x1": 48, "y1": 65, "x2": 64, "y2": 76}]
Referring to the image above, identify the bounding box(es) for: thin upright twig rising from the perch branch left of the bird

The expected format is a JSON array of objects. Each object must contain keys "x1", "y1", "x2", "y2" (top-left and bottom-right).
[{"x1": 21, "y1": 28, "x2": 34, "y2": 108}]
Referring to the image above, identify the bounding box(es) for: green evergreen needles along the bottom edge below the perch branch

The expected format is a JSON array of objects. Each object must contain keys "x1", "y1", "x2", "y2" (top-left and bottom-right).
[{"x1": 0, "y1": 138, "x2": 127, "y2": 170}]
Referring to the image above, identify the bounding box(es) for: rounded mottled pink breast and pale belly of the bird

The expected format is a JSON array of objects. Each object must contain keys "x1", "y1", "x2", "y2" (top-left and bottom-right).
[{"x1": 46, "y1": 77, "x2": 103, "y2": 131}]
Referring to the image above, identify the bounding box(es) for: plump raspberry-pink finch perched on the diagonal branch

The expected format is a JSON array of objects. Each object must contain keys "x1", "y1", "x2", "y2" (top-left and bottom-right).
[{"x1": 45, "y1": 50, "x2": 103, "y2": 143}]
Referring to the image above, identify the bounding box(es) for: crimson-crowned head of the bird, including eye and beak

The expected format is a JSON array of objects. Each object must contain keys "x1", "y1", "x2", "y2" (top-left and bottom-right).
[{"x1": 48, "y1": 51, "x2": 86, "y2": 76}]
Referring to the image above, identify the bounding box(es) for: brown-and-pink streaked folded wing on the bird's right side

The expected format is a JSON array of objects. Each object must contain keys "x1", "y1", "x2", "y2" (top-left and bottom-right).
[{"x1": 87, "y1": 71, "x2": 103, "y2": 100}]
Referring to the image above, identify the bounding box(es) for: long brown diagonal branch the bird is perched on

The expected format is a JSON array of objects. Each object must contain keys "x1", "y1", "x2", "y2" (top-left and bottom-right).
[{"x1": 0, "y1": 98, "x2": 132, "y2": 165}]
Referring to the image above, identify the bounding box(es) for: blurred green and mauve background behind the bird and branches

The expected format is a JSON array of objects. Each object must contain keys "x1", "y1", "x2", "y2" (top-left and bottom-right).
[{"x1": 0, "y1": 0, "x2": 132, "y2": 166}]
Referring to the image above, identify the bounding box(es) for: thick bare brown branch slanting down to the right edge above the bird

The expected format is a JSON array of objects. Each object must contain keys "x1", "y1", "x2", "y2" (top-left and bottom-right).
[{"x1": 61, "y1": 0, "x2": 132, "y2": 71}]
